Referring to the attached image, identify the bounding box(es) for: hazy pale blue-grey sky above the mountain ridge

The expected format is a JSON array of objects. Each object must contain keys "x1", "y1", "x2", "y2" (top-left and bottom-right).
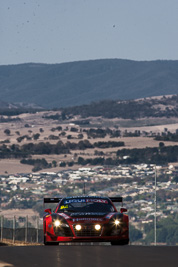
[{"x1": 0, "y1": 0, "x2": 178, "y2": 65}]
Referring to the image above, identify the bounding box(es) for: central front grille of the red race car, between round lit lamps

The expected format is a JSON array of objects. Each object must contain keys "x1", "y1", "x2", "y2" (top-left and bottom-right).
[{"x1": 73, "y1": 224, "x2": 102, "y2": 237}]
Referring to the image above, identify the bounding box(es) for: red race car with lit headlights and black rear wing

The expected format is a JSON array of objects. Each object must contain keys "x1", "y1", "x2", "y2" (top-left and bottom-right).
[{"x1": 43, "y1": 196, "x2": 129, "y2": 245}]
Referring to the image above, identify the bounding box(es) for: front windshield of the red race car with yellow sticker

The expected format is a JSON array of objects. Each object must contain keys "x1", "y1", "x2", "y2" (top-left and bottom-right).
[{"x1": 58, "y1": 198, "x2": 115, "y2": 212}]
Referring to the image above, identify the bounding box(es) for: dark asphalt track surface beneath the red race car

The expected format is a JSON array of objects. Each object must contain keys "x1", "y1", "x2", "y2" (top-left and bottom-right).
[{"x1": 0, "y1": 245, "x2": 178, "y2": 267}]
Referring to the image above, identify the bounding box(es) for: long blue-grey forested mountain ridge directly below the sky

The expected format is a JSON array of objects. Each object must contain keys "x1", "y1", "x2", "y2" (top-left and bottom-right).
[{"x1": 0, "y1": 59, "x2": 178, "y2": 108}]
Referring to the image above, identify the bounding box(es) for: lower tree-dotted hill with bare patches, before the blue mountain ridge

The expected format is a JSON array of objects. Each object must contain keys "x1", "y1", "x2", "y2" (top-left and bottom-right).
[{"x1": 46, "y1": 95, "x2": 178, "y2": 119}]
